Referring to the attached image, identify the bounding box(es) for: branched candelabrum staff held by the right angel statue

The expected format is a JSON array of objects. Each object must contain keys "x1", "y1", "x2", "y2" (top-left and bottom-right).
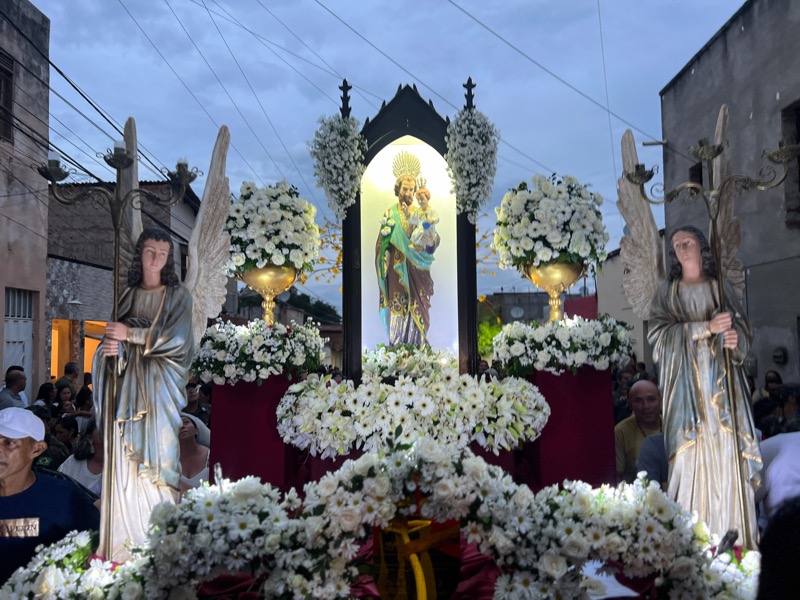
[{"x1": 622, "y1": 126, "x2": 800, "y2": 548}]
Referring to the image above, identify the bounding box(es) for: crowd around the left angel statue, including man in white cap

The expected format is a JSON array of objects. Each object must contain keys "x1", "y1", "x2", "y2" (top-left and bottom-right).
[{"x1": 0, "y1": 362, "x2": 216, "y2": 585}]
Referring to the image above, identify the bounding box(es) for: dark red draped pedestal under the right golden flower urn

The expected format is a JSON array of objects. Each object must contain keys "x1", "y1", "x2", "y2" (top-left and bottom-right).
[{"x1": 526, "y1": 367, "x2": 616, "y2": 489}]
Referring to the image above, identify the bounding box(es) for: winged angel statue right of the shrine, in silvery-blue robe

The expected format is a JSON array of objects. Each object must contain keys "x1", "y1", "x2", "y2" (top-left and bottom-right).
[{"x1": 617, "y1": 107, "x2": 761, "y2": 548}]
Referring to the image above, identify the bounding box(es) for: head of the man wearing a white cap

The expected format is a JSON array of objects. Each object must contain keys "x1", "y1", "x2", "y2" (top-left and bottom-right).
[{"x1": 0, "y1": 408, "x2": 47, "y2": 488}]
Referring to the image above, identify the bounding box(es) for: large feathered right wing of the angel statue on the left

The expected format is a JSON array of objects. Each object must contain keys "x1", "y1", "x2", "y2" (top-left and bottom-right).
[{"x1": 184, "y1": 125, "x2": 231, "y2": 344}]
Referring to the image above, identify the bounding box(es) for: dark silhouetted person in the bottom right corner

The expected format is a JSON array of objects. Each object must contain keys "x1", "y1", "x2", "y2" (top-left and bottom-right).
[{"x1": 756, "y1": 497, "x2": 800, "y2": 600}]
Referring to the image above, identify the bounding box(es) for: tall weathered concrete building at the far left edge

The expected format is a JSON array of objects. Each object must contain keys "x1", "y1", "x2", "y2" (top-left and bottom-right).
[{"x1": 0, "y1": 0, "x2": 50, "y2": 398}]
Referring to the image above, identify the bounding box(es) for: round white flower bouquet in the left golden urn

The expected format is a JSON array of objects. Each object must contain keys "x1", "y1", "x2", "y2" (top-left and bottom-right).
[{"x1": 225, "y1": 181, "x2": 320, "y2": 277}]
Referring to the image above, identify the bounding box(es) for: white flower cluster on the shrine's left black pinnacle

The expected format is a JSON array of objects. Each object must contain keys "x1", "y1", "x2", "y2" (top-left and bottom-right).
[{"x1": 309, "y1": 115, "x2": 367, "y2": 220}]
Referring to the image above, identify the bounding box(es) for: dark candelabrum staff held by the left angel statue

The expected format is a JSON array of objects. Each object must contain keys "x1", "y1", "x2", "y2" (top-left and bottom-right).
[{"x1": 37, "y1": 140, "x2": 198, "y2": 558}]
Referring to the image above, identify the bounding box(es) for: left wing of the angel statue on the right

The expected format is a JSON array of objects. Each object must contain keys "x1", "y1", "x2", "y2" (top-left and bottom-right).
[{"x1": 617, "y1": 129, "x2": 666, "y2": 319}]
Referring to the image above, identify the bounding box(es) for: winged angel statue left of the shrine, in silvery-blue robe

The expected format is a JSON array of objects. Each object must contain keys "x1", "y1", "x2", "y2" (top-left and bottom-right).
[{"x1": 92, "y1": 126, "x2": 230, "y2": 562}]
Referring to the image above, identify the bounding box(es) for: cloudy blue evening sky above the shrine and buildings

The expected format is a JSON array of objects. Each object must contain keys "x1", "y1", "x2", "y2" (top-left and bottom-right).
[{"x1": 33, "y1": 0, "x2": 742, "y2": 307}]
